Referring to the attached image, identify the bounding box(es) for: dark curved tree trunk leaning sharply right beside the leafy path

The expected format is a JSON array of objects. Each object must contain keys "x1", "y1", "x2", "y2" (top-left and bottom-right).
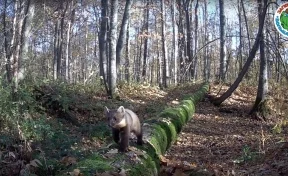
[{"x1": 213, "y1": 0, "x2": 267, "y2": 105}]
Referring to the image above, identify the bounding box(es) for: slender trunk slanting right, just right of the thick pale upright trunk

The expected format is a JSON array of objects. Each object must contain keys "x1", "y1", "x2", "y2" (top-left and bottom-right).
[{"x1": 116, "y1": 0, "x2": 133, "y2": 76}]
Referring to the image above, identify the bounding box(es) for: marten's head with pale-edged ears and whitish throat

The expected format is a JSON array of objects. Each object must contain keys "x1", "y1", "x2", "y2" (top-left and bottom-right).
[{"x1": 104, "y1": 106, "x2": 126, "y2": 128}]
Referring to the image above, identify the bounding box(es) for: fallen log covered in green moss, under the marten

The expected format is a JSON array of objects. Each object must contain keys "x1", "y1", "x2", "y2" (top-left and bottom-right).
[{"x1": 61, "y1": 83, "x2": 209, "y2": 176}]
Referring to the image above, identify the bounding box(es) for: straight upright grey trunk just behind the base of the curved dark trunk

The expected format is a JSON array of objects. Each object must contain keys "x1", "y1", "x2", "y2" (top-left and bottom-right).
[{"x1": 219, "y1": 0, "x2": 226, "y2": 82}]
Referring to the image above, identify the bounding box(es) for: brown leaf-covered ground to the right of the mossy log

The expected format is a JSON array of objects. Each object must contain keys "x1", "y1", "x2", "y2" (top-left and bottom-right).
[{"x1": 162, "y1": 86, "x2": 288, "y2": 176}]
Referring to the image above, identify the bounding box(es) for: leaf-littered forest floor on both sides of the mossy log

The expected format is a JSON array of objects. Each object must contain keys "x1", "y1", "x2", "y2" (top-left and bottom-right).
[{"x1": 0, "y1": 84, "x2": 288, "y2": 176}]
